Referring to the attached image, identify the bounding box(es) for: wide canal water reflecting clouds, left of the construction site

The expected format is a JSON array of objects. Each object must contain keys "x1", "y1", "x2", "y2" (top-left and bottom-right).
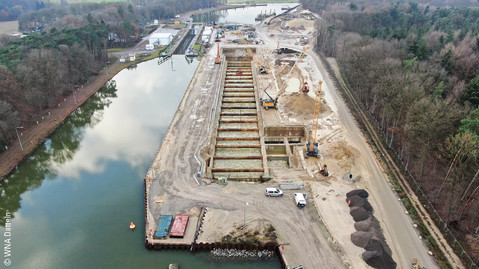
[{"x1": 0, "y1": 55, "x2": 280, "y2": 269}]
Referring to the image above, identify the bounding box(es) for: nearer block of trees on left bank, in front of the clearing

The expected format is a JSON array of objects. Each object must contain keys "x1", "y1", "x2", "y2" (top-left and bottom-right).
[{"x1": 0, "y1": 24, "x2": 108, "y2": 149}]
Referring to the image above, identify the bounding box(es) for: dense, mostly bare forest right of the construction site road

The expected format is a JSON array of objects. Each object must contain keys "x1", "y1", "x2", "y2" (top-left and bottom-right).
[{"x1": 304, "y1": 0, "x2": 479, "y2": 262}]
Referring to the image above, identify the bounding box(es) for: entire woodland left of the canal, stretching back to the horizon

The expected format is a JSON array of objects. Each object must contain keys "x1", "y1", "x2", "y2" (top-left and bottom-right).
[{"x1": 0, "y1": 0, "x2": 216, "y2": 151}]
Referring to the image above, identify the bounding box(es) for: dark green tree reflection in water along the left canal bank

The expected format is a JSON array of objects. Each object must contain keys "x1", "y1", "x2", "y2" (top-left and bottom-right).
[{"x1": 0, "y1": 81, "x2": 117, "y2": 226}]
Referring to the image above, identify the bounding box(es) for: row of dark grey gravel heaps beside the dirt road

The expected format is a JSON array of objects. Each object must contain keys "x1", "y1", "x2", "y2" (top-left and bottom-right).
[{"x1": 346, "y1": 189, "x2": 397, "y2": 268}]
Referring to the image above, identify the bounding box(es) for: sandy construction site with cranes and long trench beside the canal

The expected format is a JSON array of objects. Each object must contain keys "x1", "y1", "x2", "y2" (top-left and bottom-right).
[{"x1": 145, "y1": 6, "x2": 437, "y2": 268}]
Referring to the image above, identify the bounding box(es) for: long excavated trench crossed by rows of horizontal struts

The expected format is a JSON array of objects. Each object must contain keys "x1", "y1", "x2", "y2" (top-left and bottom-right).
[{"x1": 211, "y1": 56, "x2": 265, "y2": 180}]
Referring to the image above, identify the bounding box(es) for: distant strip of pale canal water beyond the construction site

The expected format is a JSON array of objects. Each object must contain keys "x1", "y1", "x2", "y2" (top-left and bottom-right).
[{"x1": 193, "y1": 3, "x2": 298, "y2": 24}]
